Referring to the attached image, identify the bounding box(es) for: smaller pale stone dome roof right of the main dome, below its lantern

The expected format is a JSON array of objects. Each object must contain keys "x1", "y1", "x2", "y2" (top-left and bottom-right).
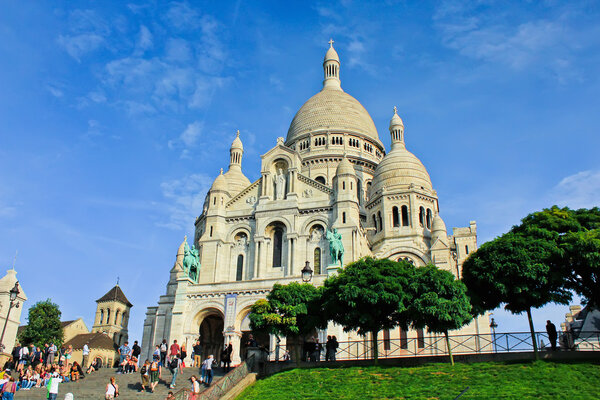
[{"x1": 371, "y1": 145, "x2": 433, "y2": 194}]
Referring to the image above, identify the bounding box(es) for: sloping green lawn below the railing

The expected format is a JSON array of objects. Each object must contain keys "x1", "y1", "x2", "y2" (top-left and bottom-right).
[{"x1": 238, "y1": 361, "x2": 600, "y2": 400}]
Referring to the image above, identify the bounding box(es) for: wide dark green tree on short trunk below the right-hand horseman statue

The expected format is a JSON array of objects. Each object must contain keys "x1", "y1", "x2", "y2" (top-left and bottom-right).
[{"x1": 323, "y1": 257, "x2": 415, "y2": 364}]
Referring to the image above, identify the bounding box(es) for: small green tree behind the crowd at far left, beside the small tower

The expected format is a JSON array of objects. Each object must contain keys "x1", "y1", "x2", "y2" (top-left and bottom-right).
[{"x1": 19, "y1": 299, "x2": 63, "y2": 347}]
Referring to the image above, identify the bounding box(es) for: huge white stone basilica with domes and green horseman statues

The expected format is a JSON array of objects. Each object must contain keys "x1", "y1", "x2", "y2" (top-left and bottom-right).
[{"x1": 142, "y1": 41, "x2": 490, "y2": 364}]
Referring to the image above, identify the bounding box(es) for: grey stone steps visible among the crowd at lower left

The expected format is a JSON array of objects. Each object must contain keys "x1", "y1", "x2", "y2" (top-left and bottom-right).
[{"x1": 15, "y1": 368, "x2": 223, "y2": 400}]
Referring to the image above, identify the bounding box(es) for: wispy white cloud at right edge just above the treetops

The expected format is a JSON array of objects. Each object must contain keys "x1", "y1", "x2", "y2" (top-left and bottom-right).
[{"x1": 551, "y1": 170, "x2": 600, "y2": 208}]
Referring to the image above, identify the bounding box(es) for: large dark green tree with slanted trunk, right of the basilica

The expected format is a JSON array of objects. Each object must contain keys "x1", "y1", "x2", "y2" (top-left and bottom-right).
[{"x1": 462, "y1": 230, "x2": 572, "y2": 358}]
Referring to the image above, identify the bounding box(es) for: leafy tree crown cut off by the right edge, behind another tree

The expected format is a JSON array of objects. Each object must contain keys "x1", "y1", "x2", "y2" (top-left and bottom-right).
[{"x1": 513, "y1": 206, "x2": 600, "y2": 307}]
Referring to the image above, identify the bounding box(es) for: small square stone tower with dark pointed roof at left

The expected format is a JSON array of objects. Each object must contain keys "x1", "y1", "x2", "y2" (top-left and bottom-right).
[{"x1": 92, "y1": 284, "x2": 133, "y2": 346}]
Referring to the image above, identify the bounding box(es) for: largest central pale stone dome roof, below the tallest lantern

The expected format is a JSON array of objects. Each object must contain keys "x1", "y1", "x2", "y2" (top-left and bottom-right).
[{"x1": 286, "y1": 88, "x2": 380, "y2": 144}]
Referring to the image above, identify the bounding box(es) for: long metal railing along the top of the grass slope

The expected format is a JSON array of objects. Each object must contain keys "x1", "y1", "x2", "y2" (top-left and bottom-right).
[{"x1": 269, "y1": 331, "x2": 600, "y2": 361}]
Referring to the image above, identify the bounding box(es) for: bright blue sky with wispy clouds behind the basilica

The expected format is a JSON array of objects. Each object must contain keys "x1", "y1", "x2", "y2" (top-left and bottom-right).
[{"x1": 0, "y1": 1, "x2": 600, "y2": 340}]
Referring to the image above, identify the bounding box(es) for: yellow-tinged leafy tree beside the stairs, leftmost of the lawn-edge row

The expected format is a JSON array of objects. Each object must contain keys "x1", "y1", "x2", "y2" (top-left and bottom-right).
[{"x1": 250, "y1": 282, "x2": 327, "y2": 362}]
